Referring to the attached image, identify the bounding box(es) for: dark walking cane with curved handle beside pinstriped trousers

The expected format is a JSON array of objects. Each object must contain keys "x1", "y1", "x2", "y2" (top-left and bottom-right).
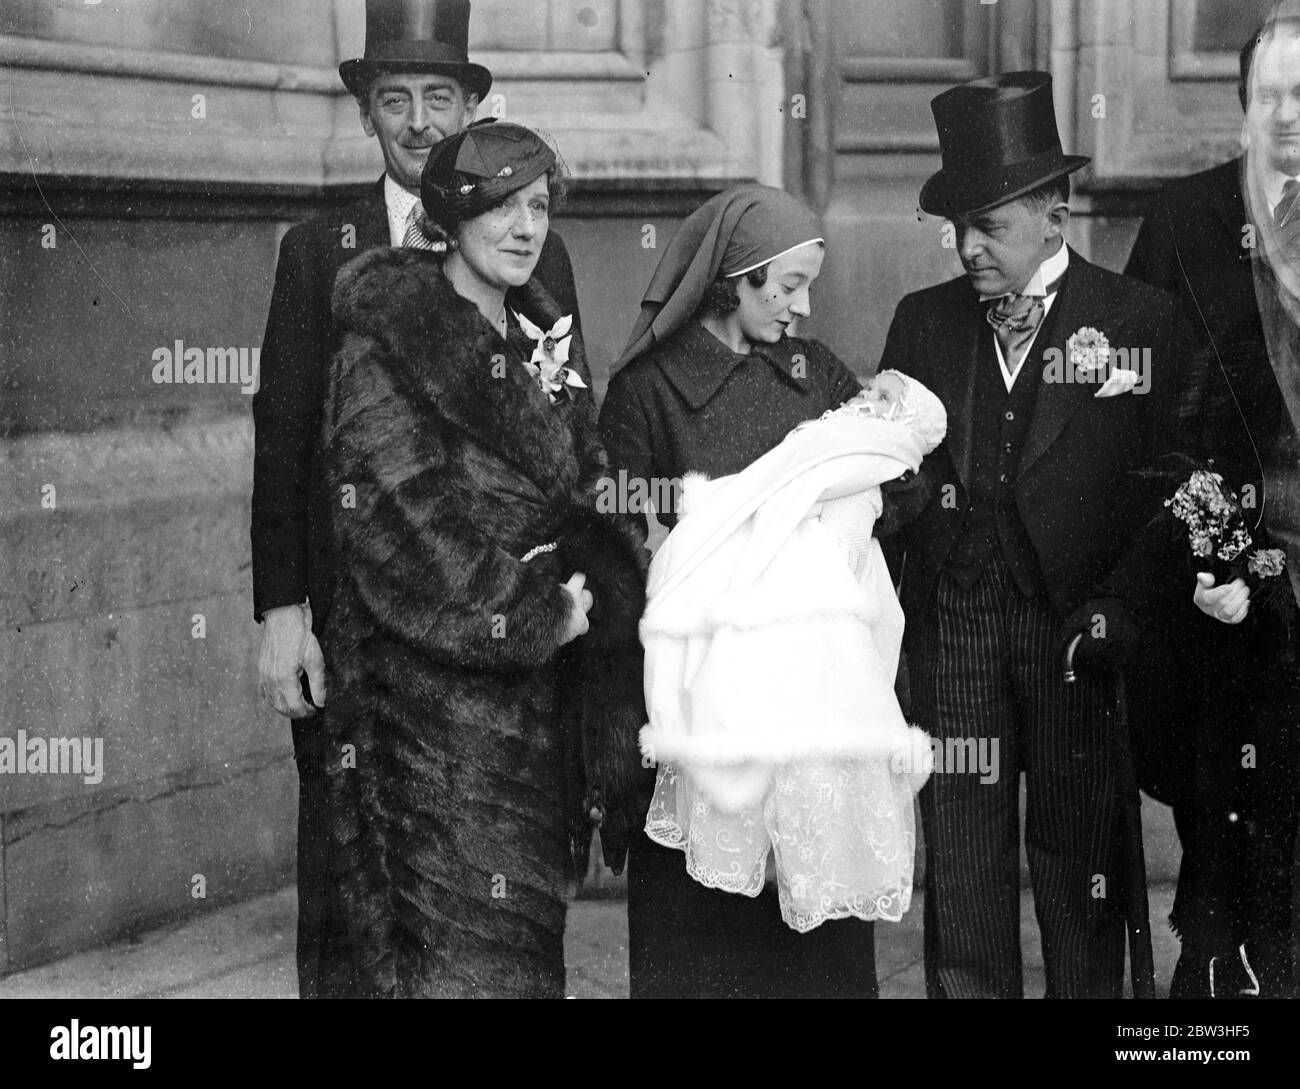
[{"x1": 1065, "y1": 632, "x2": 1156, "y2": 998}]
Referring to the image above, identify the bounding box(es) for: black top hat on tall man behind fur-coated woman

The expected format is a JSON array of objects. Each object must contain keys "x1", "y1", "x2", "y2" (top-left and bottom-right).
[{"x1": 338, "y1": 0, "x2": 491, "y2": 99}]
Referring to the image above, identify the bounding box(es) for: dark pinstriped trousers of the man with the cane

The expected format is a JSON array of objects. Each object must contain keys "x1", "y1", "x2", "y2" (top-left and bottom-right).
[{"x1": 909, "y1": 551, "x2": 1126, "y2": 998}]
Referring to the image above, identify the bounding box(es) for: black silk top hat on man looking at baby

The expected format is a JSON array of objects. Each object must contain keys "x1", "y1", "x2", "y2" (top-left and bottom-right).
[{"x1": 920, "y1": 71, "x2": 1092, "y2": 218}]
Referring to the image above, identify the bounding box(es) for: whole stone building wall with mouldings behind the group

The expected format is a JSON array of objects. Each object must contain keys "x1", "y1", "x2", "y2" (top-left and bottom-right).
[{"x1": 0, "y1": 0, "x2": 1234, "y2": 973}]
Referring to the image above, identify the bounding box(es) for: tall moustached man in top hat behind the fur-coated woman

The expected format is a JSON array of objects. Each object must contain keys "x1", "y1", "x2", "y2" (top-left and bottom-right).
[{"x1": 252, "y1": 0, "x2": 577, "y2": 998}]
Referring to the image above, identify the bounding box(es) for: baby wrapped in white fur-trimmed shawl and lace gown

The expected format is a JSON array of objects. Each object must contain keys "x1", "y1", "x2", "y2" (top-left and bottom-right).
[{"x1": 641, "y1": 372, "x2": 946, "y2": 932}]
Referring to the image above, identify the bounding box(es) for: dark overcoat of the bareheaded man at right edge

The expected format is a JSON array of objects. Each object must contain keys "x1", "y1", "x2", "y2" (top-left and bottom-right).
[{"x1": 1126, "y1": 159, "x2": 1300, "y2": 997}]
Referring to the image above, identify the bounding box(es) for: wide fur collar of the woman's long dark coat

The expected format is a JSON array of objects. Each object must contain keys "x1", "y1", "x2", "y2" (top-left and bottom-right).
[{"x1": 333, "y1": 247, "x2": 592, "y2": 494}]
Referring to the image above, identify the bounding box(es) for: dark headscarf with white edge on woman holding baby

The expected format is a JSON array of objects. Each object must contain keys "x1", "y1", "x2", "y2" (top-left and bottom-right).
[{"x1": 614, "y1": 185, "x2": 824, "y2": 372}]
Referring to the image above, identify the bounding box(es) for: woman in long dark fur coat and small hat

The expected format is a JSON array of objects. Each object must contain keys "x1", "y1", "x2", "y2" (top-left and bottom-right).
[{"x1": 310, "y1": 123, "x2": 645, "y2": 997}]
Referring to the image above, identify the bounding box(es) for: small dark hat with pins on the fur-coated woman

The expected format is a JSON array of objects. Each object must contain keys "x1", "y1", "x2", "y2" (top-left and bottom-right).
[{"x1": 420, "y1": 117, "x2": 555, "y2": 230}]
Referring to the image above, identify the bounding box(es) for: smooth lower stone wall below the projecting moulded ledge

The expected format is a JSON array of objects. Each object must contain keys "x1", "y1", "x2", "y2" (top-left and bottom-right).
[{"x1": 0, "y1": 191, "x2": 701, "y2": 971}]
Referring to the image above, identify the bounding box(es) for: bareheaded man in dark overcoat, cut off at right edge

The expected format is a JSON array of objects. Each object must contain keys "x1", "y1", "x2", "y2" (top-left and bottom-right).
[{"x1": 1125, "y1": 19, "x2": 1300, "y2": 998}]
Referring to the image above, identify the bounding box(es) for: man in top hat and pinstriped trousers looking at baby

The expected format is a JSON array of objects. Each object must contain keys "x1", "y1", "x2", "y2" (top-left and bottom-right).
[{"x1": 880, "y1": 71, "x2": 1183, "y2": 998}]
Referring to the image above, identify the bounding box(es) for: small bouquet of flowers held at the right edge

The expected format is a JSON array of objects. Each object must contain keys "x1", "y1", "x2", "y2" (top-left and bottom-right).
[{"x1": 1165, "y1": 469, "x2": 1291, "y2": 646}]
